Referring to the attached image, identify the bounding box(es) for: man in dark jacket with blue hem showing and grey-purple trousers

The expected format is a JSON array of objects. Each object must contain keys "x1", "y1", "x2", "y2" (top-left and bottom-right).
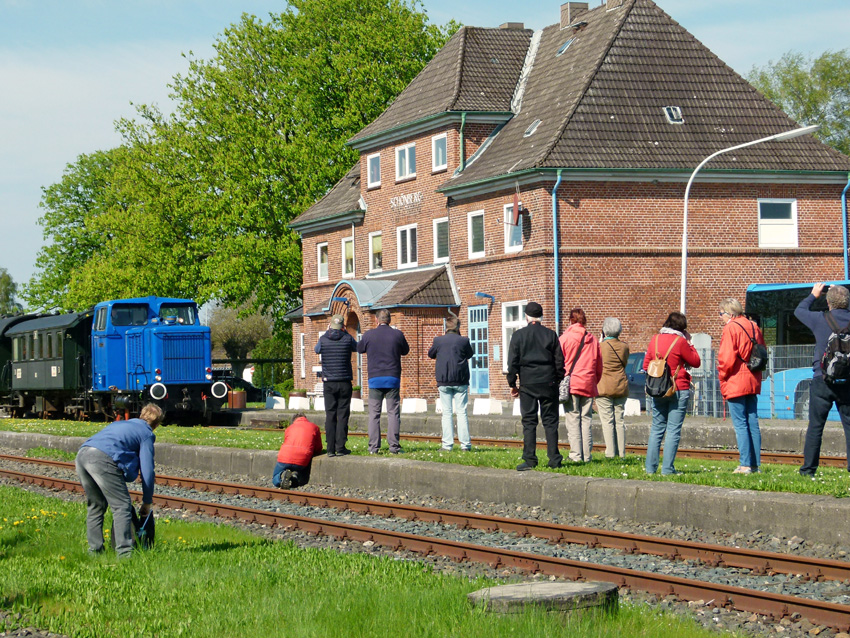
[{"x1": 357, "y1": 309, "x2": 410, "y2": 454}]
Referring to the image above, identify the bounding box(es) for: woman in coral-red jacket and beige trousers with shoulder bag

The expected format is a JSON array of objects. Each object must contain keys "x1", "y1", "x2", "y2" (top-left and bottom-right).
[{"x1": 559, "y1": 308, "x2": 602, "y2": 463}]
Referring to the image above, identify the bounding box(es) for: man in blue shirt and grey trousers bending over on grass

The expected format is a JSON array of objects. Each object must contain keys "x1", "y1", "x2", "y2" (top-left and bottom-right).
[{"x1": 76, "y1": 403, "x2": 163, "y2": 556}]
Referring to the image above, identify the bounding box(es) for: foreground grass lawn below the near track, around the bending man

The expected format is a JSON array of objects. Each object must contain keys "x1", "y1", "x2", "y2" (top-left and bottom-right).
[{"x1": 0, "y1": 486, "x2": 728, "y2": 638}]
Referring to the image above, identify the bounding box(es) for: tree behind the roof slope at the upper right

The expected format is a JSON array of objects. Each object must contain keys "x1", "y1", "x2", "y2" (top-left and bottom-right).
[{"x1": 747, "y1": 49, "x2": 850, "y2": 155}]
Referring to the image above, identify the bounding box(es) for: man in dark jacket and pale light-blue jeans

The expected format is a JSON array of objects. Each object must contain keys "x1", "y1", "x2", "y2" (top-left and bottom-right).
[{"x1": 428, "y1": 317, "x2": 473, "y2": 452}]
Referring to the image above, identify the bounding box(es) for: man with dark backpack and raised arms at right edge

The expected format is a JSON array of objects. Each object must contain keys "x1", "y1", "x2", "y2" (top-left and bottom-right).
[{"x1": 794, "y1": 283, "x2": 850, "y2": 476}]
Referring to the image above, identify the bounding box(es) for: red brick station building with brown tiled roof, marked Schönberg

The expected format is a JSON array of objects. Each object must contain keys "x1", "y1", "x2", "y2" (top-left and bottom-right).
[{"x1": 291, "y1": 0, "x2": 850, "y2": 398}]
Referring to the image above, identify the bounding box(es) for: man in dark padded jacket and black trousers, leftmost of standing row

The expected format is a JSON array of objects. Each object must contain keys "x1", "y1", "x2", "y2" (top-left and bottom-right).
[{"x1": 315, "y1": 315, "x2": 357, "y2": 456}]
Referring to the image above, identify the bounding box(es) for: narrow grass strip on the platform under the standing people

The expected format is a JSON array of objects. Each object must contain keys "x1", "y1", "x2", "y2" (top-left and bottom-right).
[{"x1": 0, "y1": 419, "x2": 850, "y2": 498}]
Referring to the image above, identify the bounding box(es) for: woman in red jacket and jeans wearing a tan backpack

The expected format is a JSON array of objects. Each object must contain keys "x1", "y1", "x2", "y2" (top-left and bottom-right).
[{"x1": 643, "y1": 312, "x2": 700, "y2": 476}]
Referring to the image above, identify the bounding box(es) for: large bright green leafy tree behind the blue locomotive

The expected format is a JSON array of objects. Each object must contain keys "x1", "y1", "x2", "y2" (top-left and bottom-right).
[{"x1": 31, "y1": 0, "x2": 456, "y2": 318}]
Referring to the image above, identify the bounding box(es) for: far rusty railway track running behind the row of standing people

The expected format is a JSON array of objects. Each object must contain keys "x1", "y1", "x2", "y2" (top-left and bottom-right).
[{"x1": 242, "y1": 428, "x2": 847, "y2": 467}]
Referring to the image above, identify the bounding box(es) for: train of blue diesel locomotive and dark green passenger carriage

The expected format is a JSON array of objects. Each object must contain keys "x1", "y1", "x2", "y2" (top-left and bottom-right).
[{"x1": 0, "y1": 297, "x2": 228, "y2": 422}]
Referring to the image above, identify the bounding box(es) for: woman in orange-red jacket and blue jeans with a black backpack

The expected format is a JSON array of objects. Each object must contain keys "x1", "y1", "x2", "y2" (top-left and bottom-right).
[{"x1": 717, "y1": 299, "x2": 764, "y2": 474}]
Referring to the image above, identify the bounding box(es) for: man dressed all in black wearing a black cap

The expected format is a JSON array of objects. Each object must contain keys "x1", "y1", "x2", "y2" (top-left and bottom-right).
[{"x1": 508, "y1": 301, "x2": 564, "y2": 472}]
